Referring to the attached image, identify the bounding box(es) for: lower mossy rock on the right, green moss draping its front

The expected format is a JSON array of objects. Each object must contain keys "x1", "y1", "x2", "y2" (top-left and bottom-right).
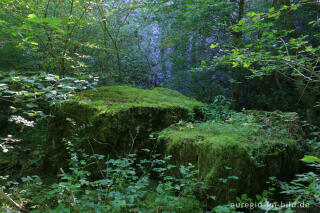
[{"x1": 158, "y1": 113, "x2": 303, "y2": 204}]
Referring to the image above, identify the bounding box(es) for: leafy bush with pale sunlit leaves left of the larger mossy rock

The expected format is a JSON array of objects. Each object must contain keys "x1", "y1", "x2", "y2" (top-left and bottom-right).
[{"x1": 0, "y1": 72, "x2": 97, "y2": 210}]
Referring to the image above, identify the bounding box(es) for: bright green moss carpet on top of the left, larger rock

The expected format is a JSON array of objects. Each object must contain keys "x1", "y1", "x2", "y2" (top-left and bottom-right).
[{"x1": 75, "y1": 86, "x2": 204, "y2": 114}]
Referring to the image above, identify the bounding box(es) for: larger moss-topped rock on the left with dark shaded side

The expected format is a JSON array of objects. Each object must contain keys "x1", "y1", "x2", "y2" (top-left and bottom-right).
[{"x1": 48, "y1": 86, "x2": 204, "y2": 172}]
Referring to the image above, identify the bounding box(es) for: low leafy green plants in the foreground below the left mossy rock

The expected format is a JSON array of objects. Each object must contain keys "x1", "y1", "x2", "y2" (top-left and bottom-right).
[{"x1": 2, "y1": 144, "x2": 202, "y2": 212}]
